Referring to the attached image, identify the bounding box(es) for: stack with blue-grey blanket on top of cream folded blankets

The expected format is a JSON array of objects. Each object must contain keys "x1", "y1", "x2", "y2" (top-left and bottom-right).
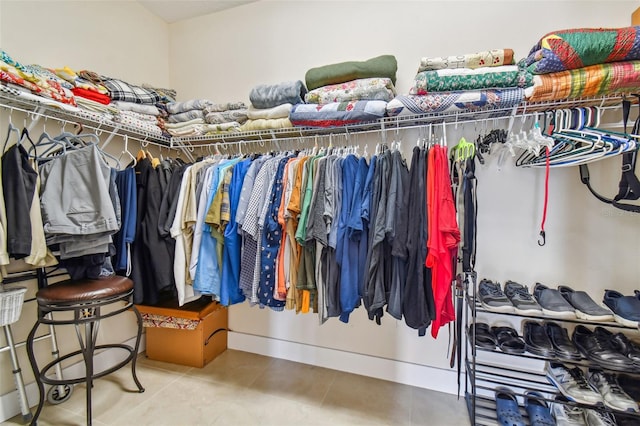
[{"x1": 241, "y1": 80, "x2": 307, "y2": 131}]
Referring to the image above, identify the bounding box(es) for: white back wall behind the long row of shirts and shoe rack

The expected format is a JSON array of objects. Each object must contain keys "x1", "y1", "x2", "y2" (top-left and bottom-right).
[{"x1": 169, "y1": 1, "x2": 640, "y2": 389}]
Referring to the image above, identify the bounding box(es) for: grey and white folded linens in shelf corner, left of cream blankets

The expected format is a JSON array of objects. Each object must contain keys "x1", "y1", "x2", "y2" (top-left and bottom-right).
[{"x1": 164, "y1": 99, "x2": 242, "y2": 137}]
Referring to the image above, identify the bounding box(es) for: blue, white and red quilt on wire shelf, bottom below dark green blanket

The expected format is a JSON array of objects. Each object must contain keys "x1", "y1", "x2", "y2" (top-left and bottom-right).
[{"x1": 289, "y1": 101, "x2": 387, "y2": 127}]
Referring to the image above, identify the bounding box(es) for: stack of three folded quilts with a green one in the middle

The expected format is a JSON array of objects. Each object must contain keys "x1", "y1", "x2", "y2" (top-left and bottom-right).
[{"x1": 387, "y1": 49, "x2": 533, "y2": 116}]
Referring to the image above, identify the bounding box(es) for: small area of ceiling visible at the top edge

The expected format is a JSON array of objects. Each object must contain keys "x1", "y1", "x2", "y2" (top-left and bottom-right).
[{"x1": 139, "y1": 0, "x2": 257, "y2": 23}]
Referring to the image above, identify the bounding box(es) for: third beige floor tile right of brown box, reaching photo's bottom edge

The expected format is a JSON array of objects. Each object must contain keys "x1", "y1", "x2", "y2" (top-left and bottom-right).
[{"x1": 322, "y1": 373, "x2": 412, "y2": 425}]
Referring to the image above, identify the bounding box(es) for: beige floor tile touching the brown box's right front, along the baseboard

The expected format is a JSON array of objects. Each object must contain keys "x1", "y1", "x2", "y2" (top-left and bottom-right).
[{"x1": 188, "y1": 350, "x2": 273, "y2": 386}]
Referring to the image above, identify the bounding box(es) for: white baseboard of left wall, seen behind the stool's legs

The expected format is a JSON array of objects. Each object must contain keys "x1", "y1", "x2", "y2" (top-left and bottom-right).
[{"x1": 0, "y1": 333, "x2": 146, "y2": 422}]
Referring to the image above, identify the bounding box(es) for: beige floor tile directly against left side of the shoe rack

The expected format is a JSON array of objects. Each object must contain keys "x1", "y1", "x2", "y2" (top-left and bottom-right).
[{"x1": 411, "y1": 388, "x2": 469, "y2": 426}]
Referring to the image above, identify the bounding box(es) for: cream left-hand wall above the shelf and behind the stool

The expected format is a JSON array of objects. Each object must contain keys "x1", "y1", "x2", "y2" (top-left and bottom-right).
[{"x1": 0, "y1": 0, "x2": 170, "y2": 408}]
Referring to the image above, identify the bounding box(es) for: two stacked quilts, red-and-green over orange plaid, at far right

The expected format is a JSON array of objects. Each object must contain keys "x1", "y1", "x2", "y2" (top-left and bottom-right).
[{"x1": 520, "y1": 27, "x2": 640, "y2": 102}]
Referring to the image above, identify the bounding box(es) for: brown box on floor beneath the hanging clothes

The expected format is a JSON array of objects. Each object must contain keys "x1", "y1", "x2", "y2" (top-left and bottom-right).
[{"x1": 137, "y1": 301, "x2": 228, "y2": 368}]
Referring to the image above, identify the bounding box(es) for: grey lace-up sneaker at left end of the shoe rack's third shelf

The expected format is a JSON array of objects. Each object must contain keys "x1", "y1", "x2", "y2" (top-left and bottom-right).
[{"x1": 546, "y1": 362, "x2": 602, "y2": 405}]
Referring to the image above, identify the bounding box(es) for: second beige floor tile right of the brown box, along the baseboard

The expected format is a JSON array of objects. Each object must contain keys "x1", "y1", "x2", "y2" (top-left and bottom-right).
[{"x1": 250, "y1": 359, "x2": 336, "y2": 405}]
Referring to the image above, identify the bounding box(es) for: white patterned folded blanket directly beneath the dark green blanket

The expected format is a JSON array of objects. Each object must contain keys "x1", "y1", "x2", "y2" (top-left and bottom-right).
[{"x1": 304, "y1": 78, "x2": 396, "y2": 104}]
